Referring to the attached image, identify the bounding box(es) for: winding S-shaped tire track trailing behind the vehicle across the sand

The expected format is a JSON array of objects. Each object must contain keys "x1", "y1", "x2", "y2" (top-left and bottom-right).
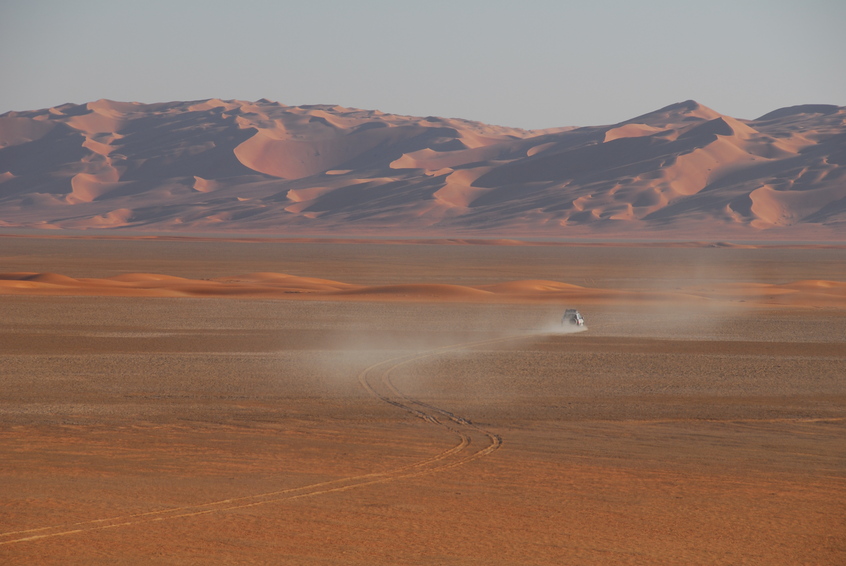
[{"x1": 0, "y1": 337, "x2": 511, "y2": 546}]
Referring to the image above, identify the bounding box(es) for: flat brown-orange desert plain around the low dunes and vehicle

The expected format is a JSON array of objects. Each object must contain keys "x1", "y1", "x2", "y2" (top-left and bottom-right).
[{"x1": 0, "y1": 239, "x2": 846, "y2": 565}]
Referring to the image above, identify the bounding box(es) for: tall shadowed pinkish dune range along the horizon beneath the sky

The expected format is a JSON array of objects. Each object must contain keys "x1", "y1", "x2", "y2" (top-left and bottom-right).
[{"x1": 0, "y1": 99, "x2": 846, "y2": 240}]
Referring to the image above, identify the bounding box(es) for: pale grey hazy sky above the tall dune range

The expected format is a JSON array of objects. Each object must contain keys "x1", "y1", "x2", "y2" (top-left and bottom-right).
[{"x1": 0, "y1": 0, "x2": 846, "y2": 128}]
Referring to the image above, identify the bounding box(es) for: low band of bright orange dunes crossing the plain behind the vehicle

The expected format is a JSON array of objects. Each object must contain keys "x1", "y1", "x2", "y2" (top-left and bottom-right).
[{"x1": 0, "y1": 273, "x2": 846, "y2": 308}]
